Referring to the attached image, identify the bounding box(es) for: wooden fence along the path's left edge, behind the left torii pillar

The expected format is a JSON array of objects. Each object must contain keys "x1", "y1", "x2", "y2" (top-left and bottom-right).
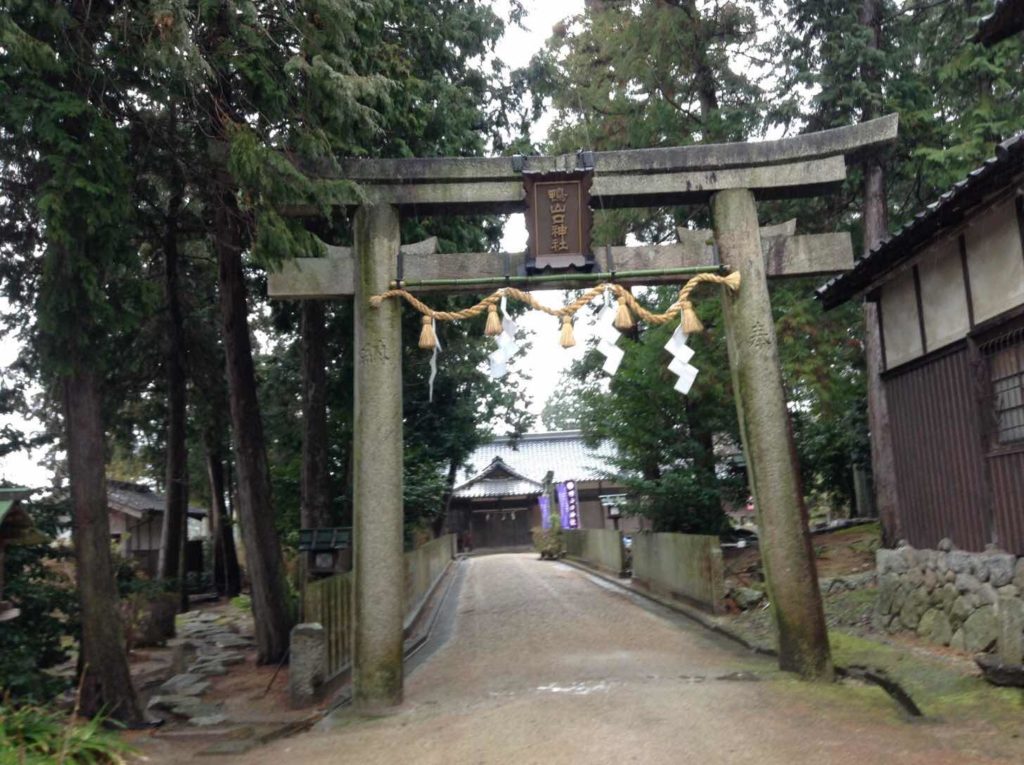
[{"x1": 302, "y1": 535, "x2": 455, "y2": 678}]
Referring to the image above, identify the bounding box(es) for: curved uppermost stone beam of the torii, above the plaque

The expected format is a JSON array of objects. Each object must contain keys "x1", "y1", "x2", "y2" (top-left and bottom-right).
[{"x1": 315, "y1": 114, "x2": 898, "y2": 183}]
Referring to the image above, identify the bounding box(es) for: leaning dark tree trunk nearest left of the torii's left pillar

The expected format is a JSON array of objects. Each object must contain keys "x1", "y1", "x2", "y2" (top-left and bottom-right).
[{"x1": 214, "y1": 184, "x2": 293, "y2": 664}]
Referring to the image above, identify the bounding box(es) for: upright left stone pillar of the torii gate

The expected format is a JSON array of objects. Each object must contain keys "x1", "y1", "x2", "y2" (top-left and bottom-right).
[{"x1": 352, "y1": 205, "x2": 406, "y2": 711}]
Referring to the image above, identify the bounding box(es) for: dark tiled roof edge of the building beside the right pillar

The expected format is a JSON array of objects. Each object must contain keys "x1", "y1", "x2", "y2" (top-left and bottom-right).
[{"x1": 817, "y1": 133, "x2": 1024, "y2": 308}]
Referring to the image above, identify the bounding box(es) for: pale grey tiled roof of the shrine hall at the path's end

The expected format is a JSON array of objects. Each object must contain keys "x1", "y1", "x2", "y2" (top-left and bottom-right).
[{"x1": 456, "y1": 430, "x2": 615, "y2": 497}]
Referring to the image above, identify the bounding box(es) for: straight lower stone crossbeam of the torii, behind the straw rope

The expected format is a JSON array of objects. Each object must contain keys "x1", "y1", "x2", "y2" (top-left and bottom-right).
[{"x1": 267, "y1": 226, "x2": 853, "y2": 299}]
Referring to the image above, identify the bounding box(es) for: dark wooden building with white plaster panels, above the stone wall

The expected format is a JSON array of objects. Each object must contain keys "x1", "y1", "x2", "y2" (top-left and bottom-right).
[{"x1": 818, "y1": 133, "x2": 1024, "y2": 555}]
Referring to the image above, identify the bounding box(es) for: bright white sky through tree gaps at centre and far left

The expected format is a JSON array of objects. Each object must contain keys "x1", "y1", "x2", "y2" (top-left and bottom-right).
[{"x1": 0, "y1": 0, "x2": 591, "y2": 486}]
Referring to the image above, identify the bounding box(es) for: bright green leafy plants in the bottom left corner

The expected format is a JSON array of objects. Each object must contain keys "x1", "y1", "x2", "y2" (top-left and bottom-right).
[{"x1": 0, "y1": 705, "x2": 132, "y2": 765}]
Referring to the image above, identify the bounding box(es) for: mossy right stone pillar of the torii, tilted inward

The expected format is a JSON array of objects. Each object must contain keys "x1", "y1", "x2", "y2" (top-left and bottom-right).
[{"x1": 712, "y1": 188, "x2": 833, "y2": 680}]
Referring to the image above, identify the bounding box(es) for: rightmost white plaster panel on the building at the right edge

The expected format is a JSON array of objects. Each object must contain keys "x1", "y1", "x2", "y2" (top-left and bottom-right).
[{"x1": 965, "y1": 199, "x2": 1024, "y2": 323}]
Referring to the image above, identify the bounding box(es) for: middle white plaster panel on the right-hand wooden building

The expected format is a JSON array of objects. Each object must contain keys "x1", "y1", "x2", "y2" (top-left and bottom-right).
[{"x1": 918, "y1": 239, "x2": 971, "y2": 352}]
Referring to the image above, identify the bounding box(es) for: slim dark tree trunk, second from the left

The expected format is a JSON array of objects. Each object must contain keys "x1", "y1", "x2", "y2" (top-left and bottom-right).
[{"x1": 157, "y1": 115, "x2": 188, "y2": 610}]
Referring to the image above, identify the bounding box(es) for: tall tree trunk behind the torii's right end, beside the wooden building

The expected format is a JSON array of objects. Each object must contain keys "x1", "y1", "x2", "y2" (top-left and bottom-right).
[{"x1": 860, "y1": 0, "x2": 902, "y2": 544}]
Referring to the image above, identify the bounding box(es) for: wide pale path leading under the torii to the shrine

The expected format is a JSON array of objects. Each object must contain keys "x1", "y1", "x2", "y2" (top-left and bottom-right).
[{"x1": 151, "y1": 555, "x2": 1024, "y2": 765}]
